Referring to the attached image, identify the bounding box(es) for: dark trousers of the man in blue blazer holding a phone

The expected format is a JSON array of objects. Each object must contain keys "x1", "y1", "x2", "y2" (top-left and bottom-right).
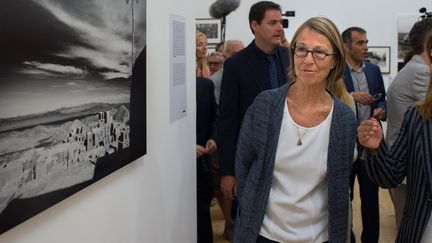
[{"x1": 350, "y1": 159, "x2": 379, "y2": 243}]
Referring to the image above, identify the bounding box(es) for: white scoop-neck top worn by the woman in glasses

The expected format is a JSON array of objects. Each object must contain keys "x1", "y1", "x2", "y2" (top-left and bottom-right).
[{"x1": 260, "y1": 99, "x2": 333, "y2": 243}]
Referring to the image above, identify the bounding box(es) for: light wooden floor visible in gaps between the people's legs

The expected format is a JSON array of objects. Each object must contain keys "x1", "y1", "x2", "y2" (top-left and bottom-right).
[{"x1": 211, "y1": 179, "x2": 396, "y2": 243}]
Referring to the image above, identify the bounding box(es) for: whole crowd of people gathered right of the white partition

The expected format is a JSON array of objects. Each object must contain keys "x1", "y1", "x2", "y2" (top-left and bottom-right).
[{"x1": 196, "y1": 1, "x2": 432, "y2": 243}]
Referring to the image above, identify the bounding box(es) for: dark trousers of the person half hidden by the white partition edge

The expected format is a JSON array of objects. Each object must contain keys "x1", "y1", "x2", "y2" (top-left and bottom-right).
[{"x1": 196, "y1": 159, "x2": 213, "y2": 243}]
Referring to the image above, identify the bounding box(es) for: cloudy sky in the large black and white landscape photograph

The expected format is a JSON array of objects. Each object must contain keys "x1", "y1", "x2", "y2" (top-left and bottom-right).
[{"x1": 0, "y1": 0, "x2": 146, "y2": 118}]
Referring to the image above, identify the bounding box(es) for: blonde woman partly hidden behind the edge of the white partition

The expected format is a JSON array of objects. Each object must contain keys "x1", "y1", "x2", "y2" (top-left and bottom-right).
[{"x1": 195, "y1": 32, "x2": 210, "y2": 78}]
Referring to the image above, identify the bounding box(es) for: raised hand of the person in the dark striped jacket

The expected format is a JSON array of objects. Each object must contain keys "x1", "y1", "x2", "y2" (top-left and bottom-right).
[{"x1": 357, "y1": 118, "x2": 383, "y2": 149}]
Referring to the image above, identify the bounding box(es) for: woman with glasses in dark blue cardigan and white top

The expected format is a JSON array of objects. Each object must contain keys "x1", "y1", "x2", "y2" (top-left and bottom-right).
[{"x1": 234, "y1": 17, "x2": 357, "y2": 243}]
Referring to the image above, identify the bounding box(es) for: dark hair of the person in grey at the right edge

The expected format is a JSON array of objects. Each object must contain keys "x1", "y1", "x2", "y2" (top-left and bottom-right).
[{"x1": 409, "y1": 18, "x2": 432, "y2": 55}]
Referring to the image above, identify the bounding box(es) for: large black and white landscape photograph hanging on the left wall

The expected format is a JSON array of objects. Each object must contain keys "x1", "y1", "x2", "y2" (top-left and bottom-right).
[{"x1": 0, "y1": 0, "x2": 146, "y2": 233}]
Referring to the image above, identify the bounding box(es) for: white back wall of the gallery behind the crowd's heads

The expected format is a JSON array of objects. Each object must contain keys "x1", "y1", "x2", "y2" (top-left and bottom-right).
[{"x1": 196, "y1": 0, "x2": 432, "y2": 88}]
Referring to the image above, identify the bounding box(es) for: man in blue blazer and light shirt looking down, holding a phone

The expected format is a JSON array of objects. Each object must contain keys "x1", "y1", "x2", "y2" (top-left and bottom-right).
[{"x1": 342, "y1": 27, "x2": 387, "y2": 243}]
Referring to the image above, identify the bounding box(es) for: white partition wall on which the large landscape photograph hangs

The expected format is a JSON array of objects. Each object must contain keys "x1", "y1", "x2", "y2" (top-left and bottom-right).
[{"x1": 0, "y1": 0, "x2": 196, "y2": 243}]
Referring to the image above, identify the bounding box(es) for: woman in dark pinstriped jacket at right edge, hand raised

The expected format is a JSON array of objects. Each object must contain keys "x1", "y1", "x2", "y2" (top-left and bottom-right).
[{"x1": 358, "y1": 35, "x2": 432, "y2": 243}]
